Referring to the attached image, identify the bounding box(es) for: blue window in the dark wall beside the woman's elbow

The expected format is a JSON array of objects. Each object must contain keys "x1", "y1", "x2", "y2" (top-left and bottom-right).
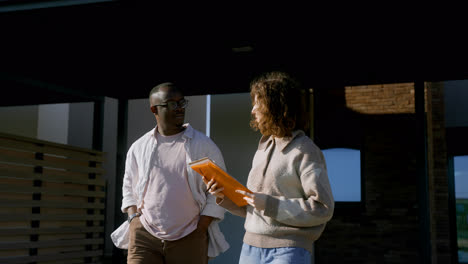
[{"x1": 322, "y1": 148, "x2": 361, "y2": 202}]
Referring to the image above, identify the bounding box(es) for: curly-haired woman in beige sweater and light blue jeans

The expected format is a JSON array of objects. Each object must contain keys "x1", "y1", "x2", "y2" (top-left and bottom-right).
[{"x1": 204, "y1": 72, "x2": 334, "y2": 264}]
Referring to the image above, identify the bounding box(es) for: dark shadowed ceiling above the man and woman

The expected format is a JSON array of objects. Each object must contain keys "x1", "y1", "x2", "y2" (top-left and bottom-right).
[{"x1": 0, "y1": 1, "x2": 468, "y2": 106}]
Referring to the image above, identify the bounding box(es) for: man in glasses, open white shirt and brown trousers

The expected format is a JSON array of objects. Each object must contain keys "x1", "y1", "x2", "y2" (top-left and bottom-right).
[{"x1": 111, "y1": 83, "x2": 229, "y2": 264}]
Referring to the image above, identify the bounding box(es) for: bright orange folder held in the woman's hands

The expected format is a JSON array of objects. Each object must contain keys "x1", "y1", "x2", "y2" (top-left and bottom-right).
[{"x1": 189, "y1": 158, "x2": 252, "y2": 207}]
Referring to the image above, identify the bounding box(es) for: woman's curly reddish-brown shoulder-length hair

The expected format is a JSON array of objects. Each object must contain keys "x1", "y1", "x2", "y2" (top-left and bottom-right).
[{"x1": 250, "y1": 71, "x2": 308, "y2": 137}]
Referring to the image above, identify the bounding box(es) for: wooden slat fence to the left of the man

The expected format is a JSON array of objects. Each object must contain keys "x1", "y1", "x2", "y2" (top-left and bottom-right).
[{"x1": 0, "y1": 133, "x2": 106, "y2": 264}]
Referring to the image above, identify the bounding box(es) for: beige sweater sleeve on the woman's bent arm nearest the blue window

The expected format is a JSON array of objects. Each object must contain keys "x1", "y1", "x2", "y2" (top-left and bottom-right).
[{"x1": 264, "y1": 152, "x2": 334, "y2": 227}]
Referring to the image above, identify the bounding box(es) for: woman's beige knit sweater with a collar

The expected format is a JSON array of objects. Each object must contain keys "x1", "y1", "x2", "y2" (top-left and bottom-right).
[{"x1": 220, "y1": 130, "x2": 334, "y2": 252}]
